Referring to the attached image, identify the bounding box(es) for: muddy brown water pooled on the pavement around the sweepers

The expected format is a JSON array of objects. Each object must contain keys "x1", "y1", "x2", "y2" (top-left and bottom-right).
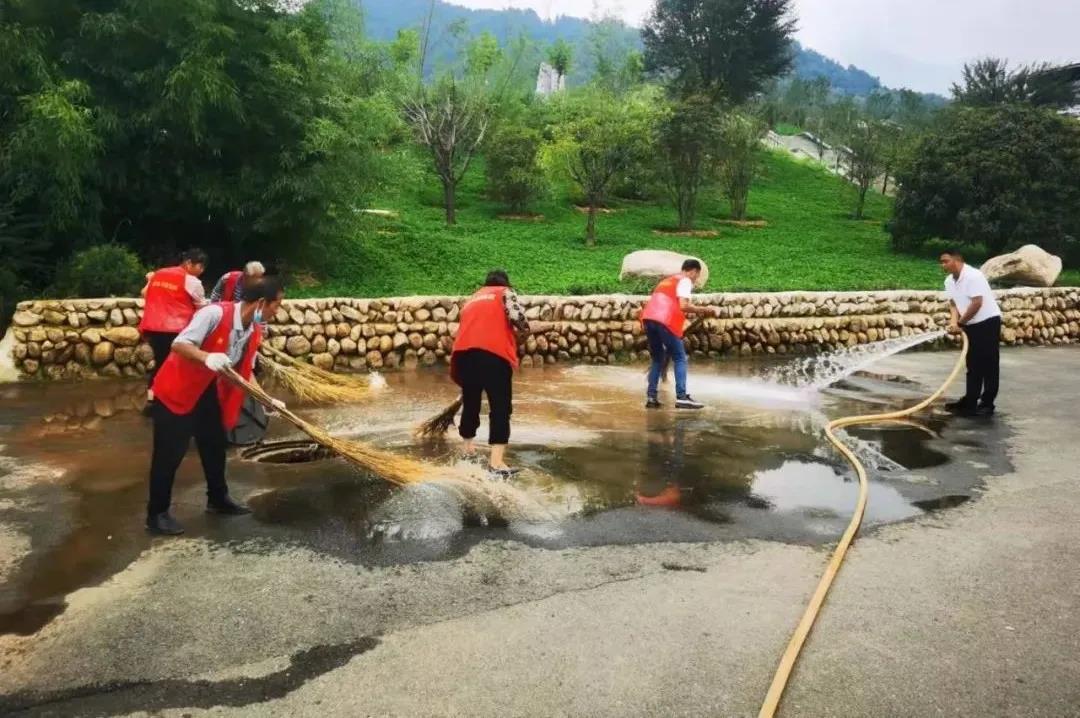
[{"x1": 0, "y1": 363, "x2": 1002, "y2": 634}]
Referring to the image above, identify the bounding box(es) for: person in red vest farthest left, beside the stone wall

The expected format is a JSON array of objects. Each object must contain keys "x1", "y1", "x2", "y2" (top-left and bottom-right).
[{"x1": 138, "y1": 249, "x2": 206, "y2": 404}]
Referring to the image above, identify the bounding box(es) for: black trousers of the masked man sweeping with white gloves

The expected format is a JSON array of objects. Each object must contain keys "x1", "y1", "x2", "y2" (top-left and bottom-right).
[{"x1": 146, "y1": 383, "x2": 229, "y2": 515}]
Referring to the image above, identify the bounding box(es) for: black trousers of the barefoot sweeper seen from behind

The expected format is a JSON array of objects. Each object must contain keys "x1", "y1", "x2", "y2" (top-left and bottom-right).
[{"x1": 454, "y1": 349, "x2": 514, "y2": 444}]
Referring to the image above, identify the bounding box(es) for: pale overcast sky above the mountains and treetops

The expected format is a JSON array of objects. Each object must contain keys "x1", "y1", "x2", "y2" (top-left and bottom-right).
[{"x1": 451, "y1": 0, "x2": 1080, "y2": 93}]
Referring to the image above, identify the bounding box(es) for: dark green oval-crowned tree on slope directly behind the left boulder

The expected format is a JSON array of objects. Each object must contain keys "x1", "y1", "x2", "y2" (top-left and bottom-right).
[{"x1": 654, "y1": 95, "x2": 720, "y2": 229}]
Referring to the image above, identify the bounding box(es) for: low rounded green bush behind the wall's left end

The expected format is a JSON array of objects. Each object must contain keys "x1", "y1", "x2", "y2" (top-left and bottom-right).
[{"x1": 52, "y1": 244, "x2": 146, "y2": 297}]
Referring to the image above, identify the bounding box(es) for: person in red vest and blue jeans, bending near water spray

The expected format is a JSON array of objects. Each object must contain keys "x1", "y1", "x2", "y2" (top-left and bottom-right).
[{"x1": 642, "y1": 259, "x2": 717, "y2": 409}]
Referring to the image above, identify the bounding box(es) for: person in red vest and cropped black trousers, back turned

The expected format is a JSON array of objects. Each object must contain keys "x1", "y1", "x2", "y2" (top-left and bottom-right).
[{"x1": 450, "y1": 269, "x2": 551, "y2": 478}]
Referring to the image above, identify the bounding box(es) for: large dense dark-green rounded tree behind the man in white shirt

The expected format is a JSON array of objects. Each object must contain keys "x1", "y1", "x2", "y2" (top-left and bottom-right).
[{"x1": 891, "y1": 105, "x2": 1080, "y2": 267}]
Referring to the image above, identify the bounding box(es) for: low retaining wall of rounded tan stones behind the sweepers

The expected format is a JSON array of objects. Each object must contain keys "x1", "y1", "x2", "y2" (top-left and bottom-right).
[{"x1": 10, "y1": 287, "x2": 1080, "y2": 379}]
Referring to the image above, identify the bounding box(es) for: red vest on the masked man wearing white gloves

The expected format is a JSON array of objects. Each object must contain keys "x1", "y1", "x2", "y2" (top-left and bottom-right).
[{"x1": 153, "y1": 301, "x2": 262, "y2": 430}]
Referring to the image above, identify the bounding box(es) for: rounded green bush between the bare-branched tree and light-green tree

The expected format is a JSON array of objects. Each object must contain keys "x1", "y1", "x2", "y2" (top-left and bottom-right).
[{"x1": 485, "y1": 124, "x2": 548, "y2": 212}]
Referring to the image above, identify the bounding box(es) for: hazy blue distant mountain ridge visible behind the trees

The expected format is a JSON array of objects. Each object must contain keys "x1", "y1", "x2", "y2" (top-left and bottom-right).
[{"x1": 357, "y1": 0, "x2": 937, "y2": 96}]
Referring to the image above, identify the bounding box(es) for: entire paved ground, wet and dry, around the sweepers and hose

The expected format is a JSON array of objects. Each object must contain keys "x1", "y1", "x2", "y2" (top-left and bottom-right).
[{"x1": 0, "y1": 348, "x2": 1080, "y2": 718}]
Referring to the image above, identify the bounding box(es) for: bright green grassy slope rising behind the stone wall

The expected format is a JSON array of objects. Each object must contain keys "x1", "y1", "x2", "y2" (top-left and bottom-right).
[{"x1": 299, "y1": 153, "x2": 1075, "y2": 297}]
